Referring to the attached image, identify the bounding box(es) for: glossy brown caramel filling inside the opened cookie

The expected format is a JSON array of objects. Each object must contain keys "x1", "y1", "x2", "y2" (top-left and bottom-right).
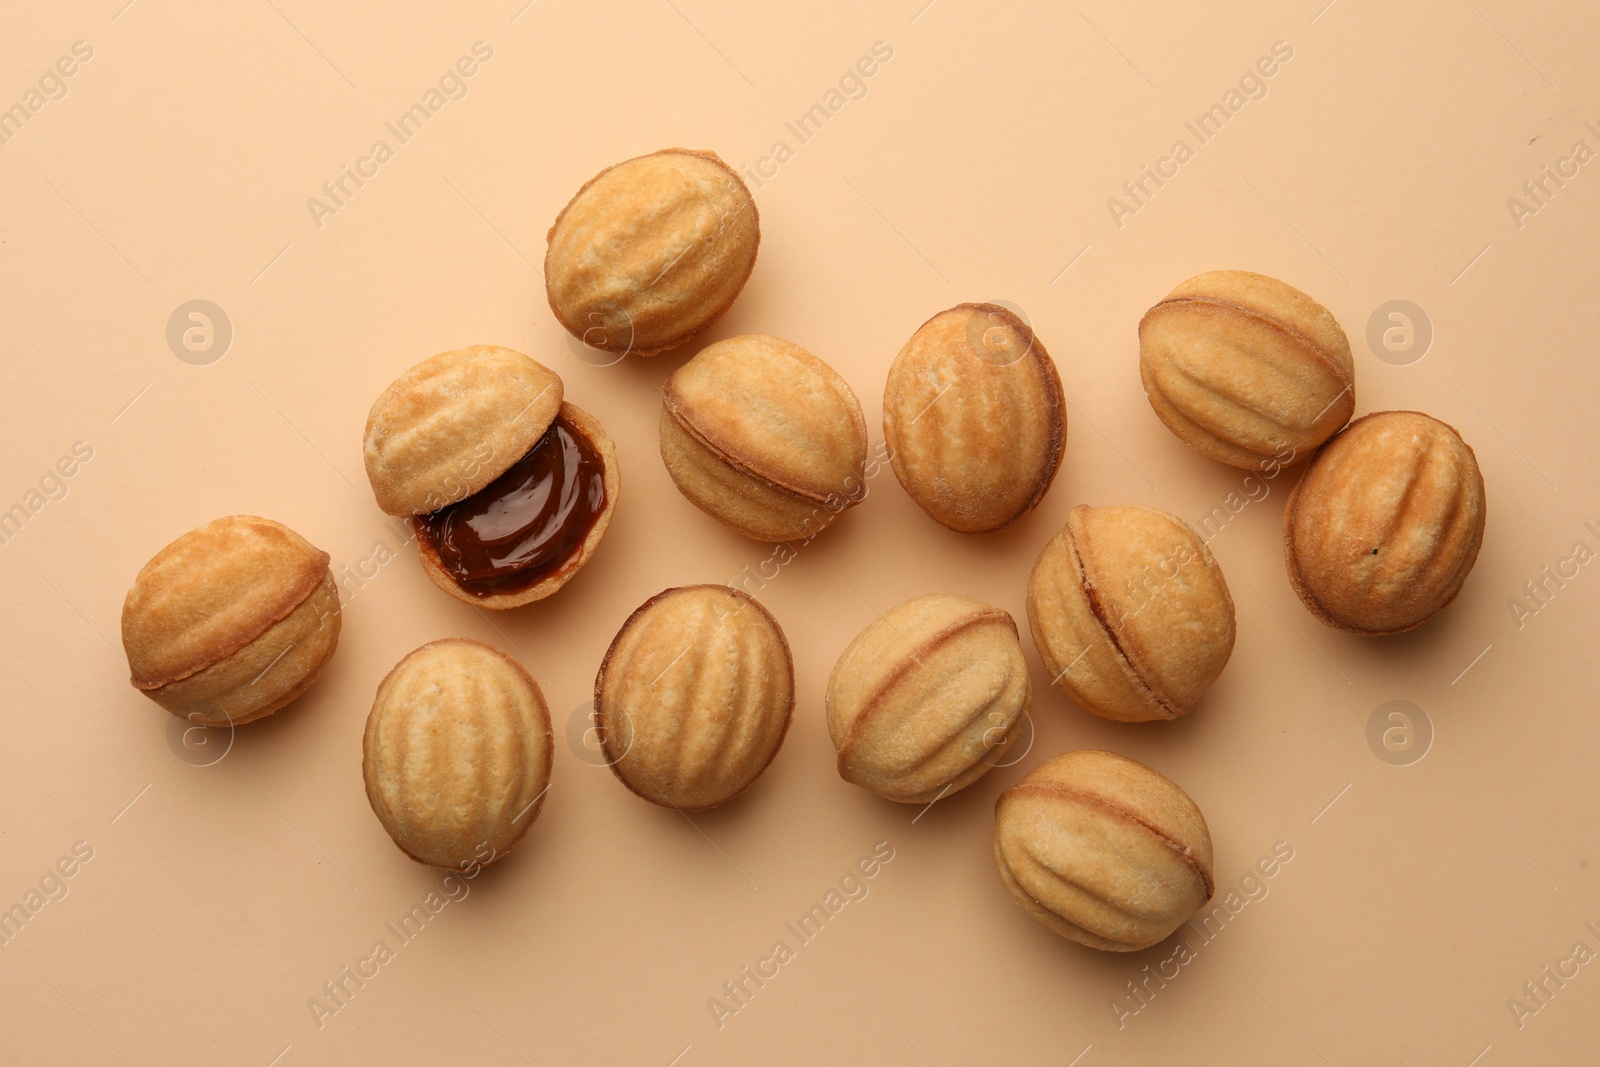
[{"x1": 411, "y1": 418, "x2": 606, "y2": 597}]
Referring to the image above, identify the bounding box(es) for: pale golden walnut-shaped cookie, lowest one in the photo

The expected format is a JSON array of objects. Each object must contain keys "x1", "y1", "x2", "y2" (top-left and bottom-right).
[{"x1": 995, "y1": 749, "x2": 1216, "y2": 952}]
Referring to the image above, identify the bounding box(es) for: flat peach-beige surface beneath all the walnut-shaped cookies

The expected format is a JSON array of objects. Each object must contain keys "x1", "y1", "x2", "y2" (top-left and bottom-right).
[{"x1": 0, "y1": 0, "x2": 1600, "y2": 1067}]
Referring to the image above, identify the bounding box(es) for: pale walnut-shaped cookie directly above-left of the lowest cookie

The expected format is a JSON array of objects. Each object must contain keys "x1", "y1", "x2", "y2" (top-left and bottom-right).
[{"x1": 826, "y1": 593, "x2": 1034, "y2": 805}]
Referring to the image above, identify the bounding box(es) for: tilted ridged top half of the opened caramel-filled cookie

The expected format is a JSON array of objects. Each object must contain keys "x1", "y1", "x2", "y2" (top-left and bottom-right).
[{"x1": 365, "y1": 344, "x2": 562, "y2": 517}]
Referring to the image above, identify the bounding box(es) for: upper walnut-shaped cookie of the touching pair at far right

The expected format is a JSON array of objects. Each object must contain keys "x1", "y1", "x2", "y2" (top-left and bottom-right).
[{"x1": 1139, "y1": 270, "x2": 1355, "y2": 470}]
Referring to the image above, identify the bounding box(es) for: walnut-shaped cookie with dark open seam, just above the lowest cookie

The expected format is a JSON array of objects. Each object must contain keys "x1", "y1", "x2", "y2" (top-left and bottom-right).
[{"x1": 1027, "y1": 506, "x2": 1234, "y2": 721}]
